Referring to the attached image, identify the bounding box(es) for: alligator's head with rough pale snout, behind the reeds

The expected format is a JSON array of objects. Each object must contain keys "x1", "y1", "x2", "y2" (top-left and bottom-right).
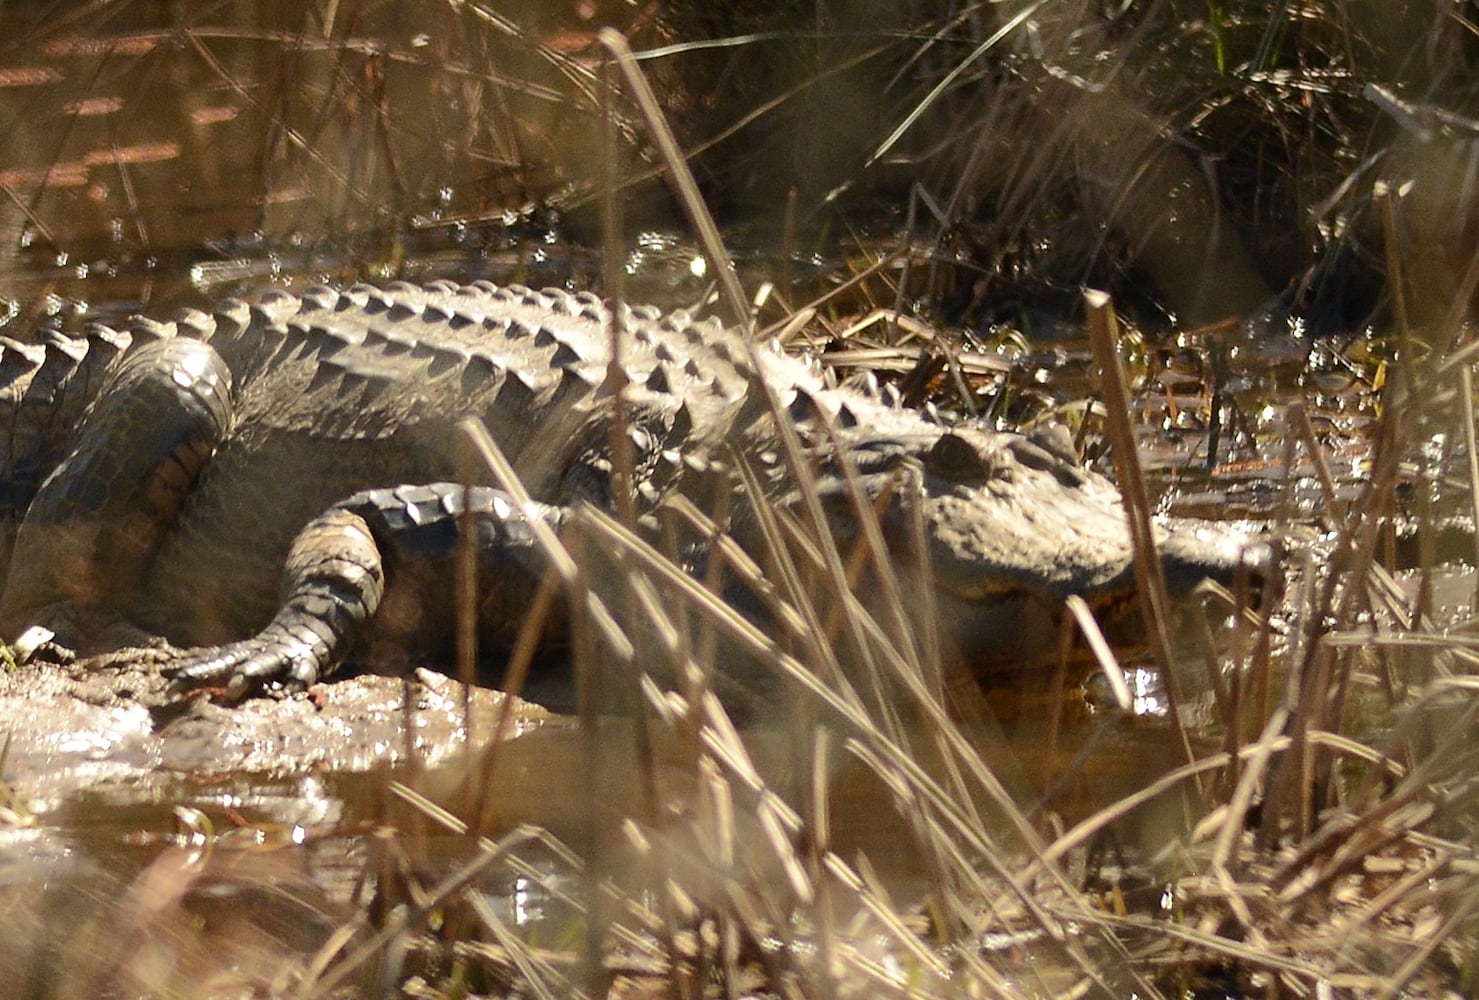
[{"x1": 792, "y1": 426, "x2": 1269, "y2": 672}]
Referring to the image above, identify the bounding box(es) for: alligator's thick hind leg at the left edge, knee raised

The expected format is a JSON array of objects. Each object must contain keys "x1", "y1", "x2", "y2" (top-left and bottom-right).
[{"x1": 0, "y1": 339, "x2": 232, "y2": 646}]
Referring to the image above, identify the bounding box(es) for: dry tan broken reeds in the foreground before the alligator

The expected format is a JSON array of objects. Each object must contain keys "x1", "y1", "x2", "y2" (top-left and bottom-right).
[{"x1": 257, "y1": 306, "x2": 1479, "y2": 997}]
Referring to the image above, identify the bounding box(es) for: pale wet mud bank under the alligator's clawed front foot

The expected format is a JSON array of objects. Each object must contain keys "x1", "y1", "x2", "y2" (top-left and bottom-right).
[{"x1": 0, "y1": 663, "x2": 550, "y2": 811}]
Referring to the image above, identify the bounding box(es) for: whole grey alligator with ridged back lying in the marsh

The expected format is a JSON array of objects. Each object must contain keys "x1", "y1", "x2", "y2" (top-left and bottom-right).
[{"x1": 0, "y1": 281, "x2": 1257, "y2": 697}]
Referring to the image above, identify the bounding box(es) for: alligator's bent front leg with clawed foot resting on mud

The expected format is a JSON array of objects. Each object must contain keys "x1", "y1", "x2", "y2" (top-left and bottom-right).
[{"x1": 169, "y1": 482, "x2": 565, "y2": 698}]
